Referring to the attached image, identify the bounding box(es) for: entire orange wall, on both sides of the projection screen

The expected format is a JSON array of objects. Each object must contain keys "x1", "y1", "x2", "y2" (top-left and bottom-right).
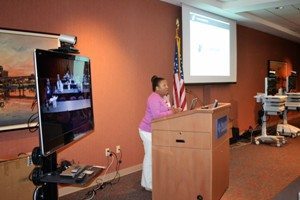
[{"x1": 0, "y1": 0, "x2": 300, "y2": 168}]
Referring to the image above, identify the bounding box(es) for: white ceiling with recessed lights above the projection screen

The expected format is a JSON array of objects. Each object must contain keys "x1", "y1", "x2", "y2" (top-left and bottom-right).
[{"x1": 161, "y1": 0, "x2": 300, "y2": 43}]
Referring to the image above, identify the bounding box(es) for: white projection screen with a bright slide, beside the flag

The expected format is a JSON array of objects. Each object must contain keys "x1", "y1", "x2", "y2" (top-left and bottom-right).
[{"x1": 182, "y1": 5, "x2": 236, "y2": 83}]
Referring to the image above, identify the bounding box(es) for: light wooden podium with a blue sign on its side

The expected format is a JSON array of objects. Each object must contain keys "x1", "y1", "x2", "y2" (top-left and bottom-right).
[{"x1": 152, "y1": 103, "x2": 230, "y2": 200}]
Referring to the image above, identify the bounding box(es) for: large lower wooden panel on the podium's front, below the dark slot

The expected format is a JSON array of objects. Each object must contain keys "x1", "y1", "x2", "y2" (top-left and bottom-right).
[{"x1": 152, "y1": 146, "x2": 211, "y2": 200}]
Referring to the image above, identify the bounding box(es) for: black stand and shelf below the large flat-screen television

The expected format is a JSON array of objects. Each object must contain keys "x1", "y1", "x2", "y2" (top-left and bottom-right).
[{"x1": 32, "y1": 150, "x2": 103, "y2": 200}]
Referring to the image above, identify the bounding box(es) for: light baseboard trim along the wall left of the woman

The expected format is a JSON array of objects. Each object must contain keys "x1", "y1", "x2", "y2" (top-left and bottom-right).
[{"x1": 58, "y1": 164, "x2": 142, "y2": 197}]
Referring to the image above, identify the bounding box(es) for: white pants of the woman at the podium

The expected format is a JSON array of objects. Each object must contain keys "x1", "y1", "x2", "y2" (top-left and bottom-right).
[{"x1": 139, "y1": 129, "x2": 152, "y2": 190}]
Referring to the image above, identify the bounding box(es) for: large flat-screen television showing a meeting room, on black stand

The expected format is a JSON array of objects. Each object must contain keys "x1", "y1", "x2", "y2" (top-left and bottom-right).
[{"x1": 34, "y1": 49, "x2": 94, "y2": 156}]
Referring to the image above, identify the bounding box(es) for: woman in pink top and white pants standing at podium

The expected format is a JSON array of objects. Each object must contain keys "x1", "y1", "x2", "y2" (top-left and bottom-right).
[{"x1": 139, "y1": 76, "x2": 181, "y2": 191}]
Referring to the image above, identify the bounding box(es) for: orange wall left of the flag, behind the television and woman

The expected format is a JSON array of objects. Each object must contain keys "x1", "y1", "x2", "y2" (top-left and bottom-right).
[{"x1": 0, "y1": 0, "x2": 180, "y2": 168}]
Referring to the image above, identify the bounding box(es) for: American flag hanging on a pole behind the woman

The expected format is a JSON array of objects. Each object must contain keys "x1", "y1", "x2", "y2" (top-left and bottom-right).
[{"x1": 173, "y1": 30, "x2": 187, "y2": 110}]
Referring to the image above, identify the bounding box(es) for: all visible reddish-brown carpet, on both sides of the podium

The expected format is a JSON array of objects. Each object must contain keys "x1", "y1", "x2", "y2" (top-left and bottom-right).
[{"x1": 60, "y1": 119, "x2": 300, "y2": 200}]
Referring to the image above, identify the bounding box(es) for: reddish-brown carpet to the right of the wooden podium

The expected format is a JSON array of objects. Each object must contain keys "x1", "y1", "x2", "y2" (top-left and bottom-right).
[{"x1": 222, "y1": 137, "x2": 300, "y2": 200}]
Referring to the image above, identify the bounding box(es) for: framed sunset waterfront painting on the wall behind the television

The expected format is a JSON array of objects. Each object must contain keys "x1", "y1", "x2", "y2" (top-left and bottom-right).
[{"x1": 0, "y1": 28, "x2": 59, "y2": 131}]
